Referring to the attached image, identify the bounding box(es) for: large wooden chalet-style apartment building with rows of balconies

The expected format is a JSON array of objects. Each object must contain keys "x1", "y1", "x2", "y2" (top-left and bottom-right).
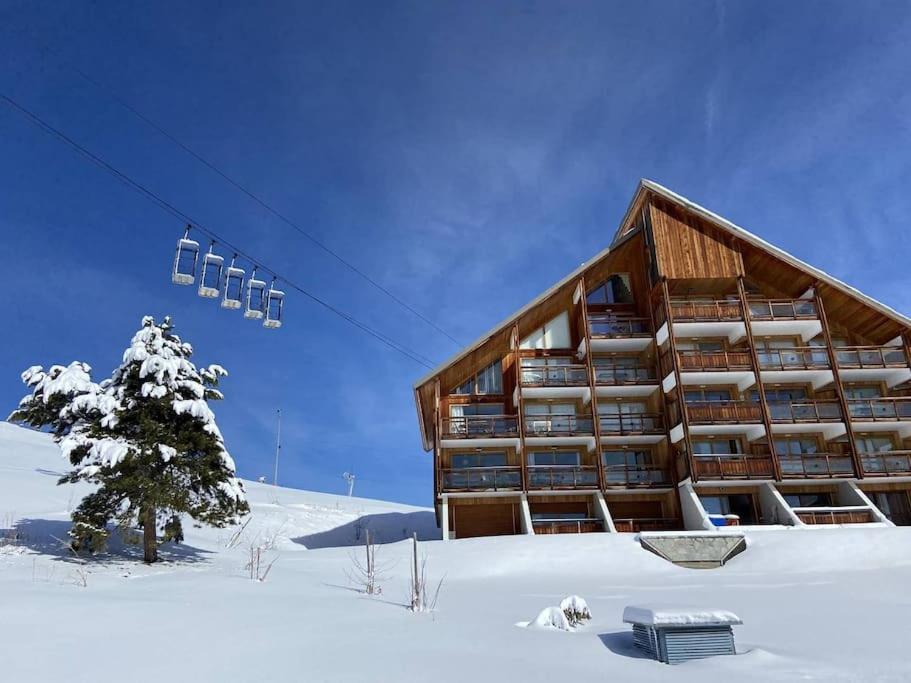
[{"x1": 415, "y1": 181, "x2": 911, "y2": 538}]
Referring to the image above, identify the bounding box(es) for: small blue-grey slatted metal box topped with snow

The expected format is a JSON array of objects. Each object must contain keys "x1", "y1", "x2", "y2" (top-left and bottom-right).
[{"x1": 623, "y1": 605, "x2": 743, "y2": 664}]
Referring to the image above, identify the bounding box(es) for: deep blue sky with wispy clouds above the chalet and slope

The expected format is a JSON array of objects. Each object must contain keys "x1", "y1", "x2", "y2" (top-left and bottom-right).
[{"x1": 0, "y1": 0, "x2": 911, "y2": 504}]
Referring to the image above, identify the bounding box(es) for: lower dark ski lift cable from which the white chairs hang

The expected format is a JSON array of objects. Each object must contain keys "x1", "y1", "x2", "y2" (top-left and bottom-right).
[{"x1": 0, "y1": 92, "x2": 433, "y2": 369}]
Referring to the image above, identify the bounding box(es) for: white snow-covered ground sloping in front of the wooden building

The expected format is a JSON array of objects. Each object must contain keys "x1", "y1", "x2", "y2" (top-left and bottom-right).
[{"x1": 0, "y1": 423, "x2": 911, "y2": 683}]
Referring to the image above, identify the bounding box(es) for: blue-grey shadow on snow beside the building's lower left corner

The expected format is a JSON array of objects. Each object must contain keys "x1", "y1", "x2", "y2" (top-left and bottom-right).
[{"x1": 292, "y1": 511, "x2": 441, "y2": 550}]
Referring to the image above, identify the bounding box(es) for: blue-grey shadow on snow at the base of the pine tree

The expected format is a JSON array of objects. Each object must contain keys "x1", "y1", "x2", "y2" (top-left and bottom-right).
[{"x1": 9, "y1": 519, "x2": 211, "y2": 564}]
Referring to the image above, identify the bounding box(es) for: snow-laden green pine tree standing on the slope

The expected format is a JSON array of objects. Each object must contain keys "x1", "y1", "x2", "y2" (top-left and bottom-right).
[{"x1": 10, "y1": 316, "x2": 249, "y2": 563}]
